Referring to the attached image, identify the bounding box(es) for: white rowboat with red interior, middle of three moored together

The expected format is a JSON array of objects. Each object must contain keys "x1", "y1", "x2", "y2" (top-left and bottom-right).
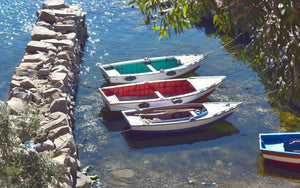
[{"x1": 99, "y1": 76, "x2": 226, "y2": 111}]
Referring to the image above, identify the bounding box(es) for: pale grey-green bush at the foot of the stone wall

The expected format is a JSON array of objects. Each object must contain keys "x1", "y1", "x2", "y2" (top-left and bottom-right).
[{"x1": 0, "y1": 103, "x2": 63, "y2": 187}]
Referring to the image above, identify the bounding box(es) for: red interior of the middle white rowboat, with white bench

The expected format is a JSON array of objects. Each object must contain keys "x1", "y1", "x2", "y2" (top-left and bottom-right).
[{"x1": 102, "y1": 80, "x2": 196, "y2": 101}]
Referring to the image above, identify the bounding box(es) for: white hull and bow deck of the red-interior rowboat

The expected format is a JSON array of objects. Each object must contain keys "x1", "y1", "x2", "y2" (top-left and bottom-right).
[{"x1": 100, "y1": 76, "x2": 226, "y2": 111}]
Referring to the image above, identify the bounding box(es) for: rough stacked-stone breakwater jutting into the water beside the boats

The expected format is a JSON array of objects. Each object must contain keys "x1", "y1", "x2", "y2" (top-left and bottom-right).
[{"x1": 7, "y1": 0, "x2": 91, "y2": 187}]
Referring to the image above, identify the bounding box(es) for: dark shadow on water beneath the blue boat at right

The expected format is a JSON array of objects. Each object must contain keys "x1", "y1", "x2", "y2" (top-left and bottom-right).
[{"x1": 256, "y1": 154, "x2": 300, "y2": 181}]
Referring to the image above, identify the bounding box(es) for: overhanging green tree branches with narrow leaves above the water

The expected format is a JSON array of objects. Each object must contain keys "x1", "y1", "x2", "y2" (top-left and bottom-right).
[{"x1": 128, "y1": 0, "x2": 300, "y2": 106}]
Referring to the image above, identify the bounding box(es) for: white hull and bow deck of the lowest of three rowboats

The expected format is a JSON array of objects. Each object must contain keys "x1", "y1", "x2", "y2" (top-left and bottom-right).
[{"x1": 122, "y1": 102, "x2": 242, "y2": 132}]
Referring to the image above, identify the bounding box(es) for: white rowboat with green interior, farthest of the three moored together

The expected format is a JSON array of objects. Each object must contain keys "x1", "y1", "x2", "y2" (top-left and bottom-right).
[{"x1": 100, "y1": 54, "x2": 207, "y2": 85}]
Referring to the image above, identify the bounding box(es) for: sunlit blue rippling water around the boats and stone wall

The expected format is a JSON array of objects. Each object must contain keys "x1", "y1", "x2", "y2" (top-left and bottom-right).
[{"x1": 0, "y1": 0, "x2": 300, "y2": 187}]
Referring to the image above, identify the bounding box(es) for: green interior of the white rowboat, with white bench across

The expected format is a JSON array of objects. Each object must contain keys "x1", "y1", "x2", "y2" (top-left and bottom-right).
[{"x1": 104, "y1": 57, "x2": 182, "y2": 74}]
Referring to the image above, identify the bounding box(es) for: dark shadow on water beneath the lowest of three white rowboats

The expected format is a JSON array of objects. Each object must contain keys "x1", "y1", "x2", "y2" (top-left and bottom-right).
[{"x1": 122, "y1": 120, "x2": 239, "y2": 149}]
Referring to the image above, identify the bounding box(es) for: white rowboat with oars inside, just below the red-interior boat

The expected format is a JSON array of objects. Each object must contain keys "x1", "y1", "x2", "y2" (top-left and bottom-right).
[{"x1": 122, "y1": 102, "x2": 242, "y2": 133}]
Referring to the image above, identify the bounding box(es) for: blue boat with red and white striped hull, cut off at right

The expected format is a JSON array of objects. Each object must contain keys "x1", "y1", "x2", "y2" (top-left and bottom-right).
[{"x1": 259, "y1": 132, "x2": 300, "y2": 167}]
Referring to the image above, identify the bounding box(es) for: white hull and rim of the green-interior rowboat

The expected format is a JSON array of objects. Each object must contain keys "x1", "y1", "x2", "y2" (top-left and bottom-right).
[{"x1": 100, "y1": 54, "x2": 206, "y2": 84}]
